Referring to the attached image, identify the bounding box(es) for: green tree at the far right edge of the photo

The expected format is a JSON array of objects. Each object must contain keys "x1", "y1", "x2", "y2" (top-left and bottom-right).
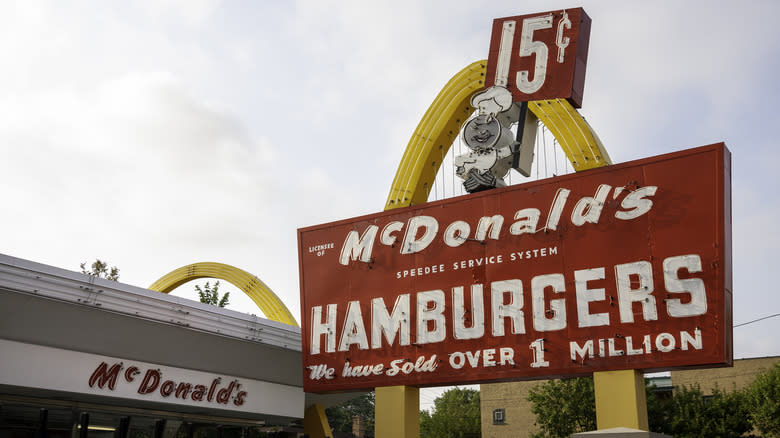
[{"x1": 745, "y1": 363, "x2": 780, "y2": 436}]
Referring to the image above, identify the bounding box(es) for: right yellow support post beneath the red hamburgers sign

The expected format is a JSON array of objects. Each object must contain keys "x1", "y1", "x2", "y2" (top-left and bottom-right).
[{"x1": 593, "y1": 370, "x2": 650, "y2": 431}]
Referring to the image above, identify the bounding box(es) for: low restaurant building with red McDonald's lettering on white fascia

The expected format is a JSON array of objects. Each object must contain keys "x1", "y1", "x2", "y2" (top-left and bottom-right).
[{"x1": 0, "y1": 254, "x2": 348, "y2": 438}]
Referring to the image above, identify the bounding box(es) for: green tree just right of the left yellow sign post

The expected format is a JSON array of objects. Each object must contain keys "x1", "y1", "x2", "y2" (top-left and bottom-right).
[{"x1": 420, "y1": 388, "x2": 482, "y2": 438}]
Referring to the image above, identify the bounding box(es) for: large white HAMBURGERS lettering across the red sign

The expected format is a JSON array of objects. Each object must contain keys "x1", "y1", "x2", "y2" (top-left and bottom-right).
[{"x1": 308, "y1": 254, "x2": 707, "y2": 356}]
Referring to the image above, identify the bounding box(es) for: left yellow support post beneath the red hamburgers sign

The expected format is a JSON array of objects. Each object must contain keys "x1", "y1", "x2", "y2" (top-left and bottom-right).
[{"x1": 374, "y1": 386, "x2": 420, "y2": 438}]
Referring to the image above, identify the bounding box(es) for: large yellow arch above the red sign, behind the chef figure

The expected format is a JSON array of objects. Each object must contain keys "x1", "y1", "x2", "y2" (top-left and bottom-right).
[{"x1": 385, "y1": 60, "x2": 612, "y2": 210}]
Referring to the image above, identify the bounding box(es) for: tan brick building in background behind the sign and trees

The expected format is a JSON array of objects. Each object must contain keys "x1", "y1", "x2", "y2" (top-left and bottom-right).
[{"x1": 480, "y1": 356, "x2": 780, "y2": 438}]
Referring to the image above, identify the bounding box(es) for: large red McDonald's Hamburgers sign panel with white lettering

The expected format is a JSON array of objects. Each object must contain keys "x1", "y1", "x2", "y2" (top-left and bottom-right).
[{"x1": 298, "y1": 143, "x2": 732, "y2": 392}]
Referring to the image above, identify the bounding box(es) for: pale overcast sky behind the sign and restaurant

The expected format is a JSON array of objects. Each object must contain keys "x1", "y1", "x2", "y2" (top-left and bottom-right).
[{"x1": 0, "y1": 0, "x2": 780, "y2": 406}]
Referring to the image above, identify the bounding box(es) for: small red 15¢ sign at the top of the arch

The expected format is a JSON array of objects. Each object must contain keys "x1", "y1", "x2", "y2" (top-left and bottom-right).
[{"x1": 485, "y1": 8, "x2": 591, "y2": 108}]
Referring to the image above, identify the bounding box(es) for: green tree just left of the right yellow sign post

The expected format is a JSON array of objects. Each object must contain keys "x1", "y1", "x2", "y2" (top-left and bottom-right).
[{"x1": 528, "y1": 377, "x2": 596, "y2": 438}]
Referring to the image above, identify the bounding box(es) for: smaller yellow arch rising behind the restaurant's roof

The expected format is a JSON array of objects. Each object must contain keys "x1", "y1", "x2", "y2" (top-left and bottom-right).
[{"x1": 149, "y1": 262, "x2": 298, "y2": 327}]
